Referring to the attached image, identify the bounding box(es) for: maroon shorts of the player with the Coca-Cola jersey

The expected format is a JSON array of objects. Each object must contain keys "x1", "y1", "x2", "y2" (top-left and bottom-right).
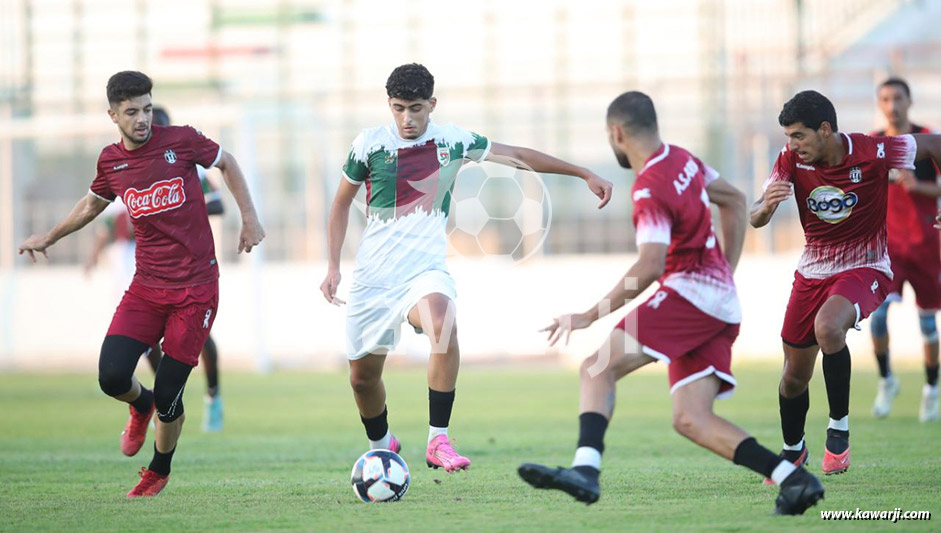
[{"x1": 108, "y1": 281, "x2": 219, "y2": 366}]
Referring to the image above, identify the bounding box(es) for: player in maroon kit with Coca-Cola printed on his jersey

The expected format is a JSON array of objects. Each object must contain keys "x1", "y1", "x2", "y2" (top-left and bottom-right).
[{"x1": 19, "y1": 71, "x2": 265, "y2": 498}]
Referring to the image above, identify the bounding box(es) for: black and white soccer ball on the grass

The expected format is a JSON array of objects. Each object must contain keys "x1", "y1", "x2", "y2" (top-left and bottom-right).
[{"x1": 350, "y1": 450, "x2": 411, "y2": 503}]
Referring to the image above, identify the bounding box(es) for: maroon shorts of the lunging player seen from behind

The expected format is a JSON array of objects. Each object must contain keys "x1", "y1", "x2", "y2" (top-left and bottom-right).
[{"x1": 616, "y1": 287, "x2": 739, "y2": 398}]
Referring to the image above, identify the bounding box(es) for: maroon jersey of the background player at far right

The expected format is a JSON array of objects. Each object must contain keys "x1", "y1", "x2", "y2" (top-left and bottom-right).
[{"x1": 873, "y1": 124, "x2": 941, "y2": 258}]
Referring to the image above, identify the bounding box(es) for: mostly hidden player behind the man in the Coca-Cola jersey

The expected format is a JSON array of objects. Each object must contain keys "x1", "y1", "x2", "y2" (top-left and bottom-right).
[{"x1": 154, "y1": 106, "x2": 224, "y2": 432}]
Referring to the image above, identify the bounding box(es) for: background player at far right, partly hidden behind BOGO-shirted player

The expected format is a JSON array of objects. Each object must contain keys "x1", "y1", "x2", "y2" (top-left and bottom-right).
[{"x1": 869, "y1": 78, "x2": 941, "y2": 422}]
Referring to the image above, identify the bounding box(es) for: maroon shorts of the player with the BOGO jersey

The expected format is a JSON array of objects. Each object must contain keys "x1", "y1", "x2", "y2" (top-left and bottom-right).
[{"x1": 781, "y1": 268, "x2": 892, "y2": 348}]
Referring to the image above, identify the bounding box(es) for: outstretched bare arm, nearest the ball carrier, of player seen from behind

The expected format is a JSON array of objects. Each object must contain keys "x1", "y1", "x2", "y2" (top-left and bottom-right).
[{"x1": 540, "y1": 243, "x2": 667, "y2": 346}]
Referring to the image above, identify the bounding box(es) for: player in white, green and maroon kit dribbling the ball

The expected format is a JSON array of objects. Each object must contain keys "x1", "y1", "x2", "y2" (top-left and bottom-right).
[{"x1": 320, "y1": 63, "x2": 611, "y2": 472}]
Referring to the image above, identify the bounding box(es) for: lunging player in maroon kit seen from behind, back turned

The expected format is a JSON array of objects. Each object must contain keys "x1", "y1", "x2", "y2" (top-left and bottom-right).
[{"x1": 519, "y1": 91, "x2": 824, "y2": 514}]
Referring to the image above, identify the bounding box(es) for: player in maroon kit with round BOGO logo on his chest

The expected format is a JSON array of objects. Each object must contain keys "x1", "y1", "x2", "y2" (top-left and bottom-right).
[{"x1": 751, "y1": 91, "x2": 916, "y2": 475}]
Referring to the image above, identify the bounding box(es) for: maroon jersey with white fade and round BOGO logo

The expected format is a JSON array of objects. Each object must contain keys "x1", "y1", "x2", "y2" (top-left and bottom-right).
[{"x1": 765, "y1": 133, "x2": 915, "y2": 279}]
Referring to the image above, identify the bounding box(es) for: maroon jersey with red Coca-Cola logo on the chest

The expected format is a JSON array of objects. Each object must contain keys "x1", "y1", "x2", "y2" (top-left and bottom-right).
[{"x1": 90, "y1": 126, "x2": 222, "y2": 288}]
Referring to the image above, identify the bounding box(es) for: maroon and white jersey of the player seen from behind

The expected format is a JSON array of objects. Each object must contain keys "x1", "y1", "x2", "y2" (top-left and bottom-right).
[{"x1": 631, "y1": 144, "x2": 742, "y2": 324}]
